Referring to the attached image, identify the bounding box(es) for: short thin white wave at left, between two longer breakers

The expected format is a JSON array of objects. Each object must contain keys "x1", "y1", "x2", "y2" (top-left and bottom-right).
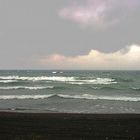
[{"x1": 0, "y1": 86, "x2": 54, "y2": 90}]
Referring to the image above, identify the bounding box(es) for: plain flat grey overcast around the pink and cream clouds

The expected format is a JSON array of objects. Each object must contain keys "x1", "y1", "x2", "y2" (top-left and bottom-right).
[{"x1": 0, "y1": 0, "x2": 140, "y2": 69}]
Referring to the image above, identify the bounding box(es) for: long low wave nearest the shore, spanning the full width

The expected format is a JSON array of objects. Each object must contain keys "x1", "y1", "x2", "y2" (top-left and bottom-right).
[{"x1": 0, "y1": 94, "x2": 140, "y2": 102}]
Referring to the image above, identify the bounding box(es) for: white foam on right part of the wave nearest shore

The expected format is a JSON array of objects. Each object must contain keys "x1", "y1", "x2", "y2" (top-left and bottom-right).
[{"x1": 57, "y1": 94, "x2": 140, "y2": 102}]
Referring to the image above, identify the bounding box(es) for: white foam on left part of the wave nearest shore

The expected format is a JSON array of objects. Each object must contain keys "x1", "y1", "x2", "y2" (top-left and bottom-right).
[{"x1": 0, "y1": 94, "x2": 53, "y2": 100}]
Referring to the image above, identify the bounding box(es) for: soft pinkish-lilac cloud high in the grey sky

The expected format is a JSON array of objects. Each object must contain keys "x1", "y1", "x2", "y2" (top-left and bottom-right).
[{"x1": 59, "y1": 0, "x2": 140, "y2": 27}]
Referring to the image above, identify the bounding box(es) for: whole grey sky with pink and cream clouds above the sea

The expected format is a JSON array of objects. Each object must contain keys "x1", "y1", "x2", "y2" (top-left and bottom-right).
[{"x1": 0, "y1": 0, "x2": 140, "y2": 70}]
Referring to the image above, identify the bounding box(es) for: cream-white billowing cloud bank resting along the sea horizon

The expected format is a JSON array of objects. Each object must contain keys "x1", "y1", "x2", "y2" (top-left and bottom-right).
[{"x1": 40, "y1": 45, "x2": 140, "y2": 70}]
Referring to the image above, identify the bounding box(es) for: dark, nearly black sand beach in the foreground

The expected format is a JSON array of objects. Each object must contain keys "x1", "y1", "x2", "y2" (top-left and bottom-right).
[{"x1": 0, "y1": 112, "x2": 140, "y2": 140}]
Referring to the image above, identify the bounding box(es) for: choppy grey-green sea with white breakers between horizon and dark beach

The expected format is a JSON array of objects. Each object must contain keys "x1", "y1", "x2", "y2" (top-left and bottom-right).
[{"x1": 0, "y1": 70, "x2": 140, "y2": 113}]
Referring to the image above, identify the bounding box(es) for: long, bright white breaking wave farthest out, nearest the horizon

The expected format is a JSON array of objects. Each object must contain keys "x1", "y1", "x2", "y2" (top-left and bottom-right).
[{"x1": 0, "y1": 76, "x2": 117, "y2": 85}]
